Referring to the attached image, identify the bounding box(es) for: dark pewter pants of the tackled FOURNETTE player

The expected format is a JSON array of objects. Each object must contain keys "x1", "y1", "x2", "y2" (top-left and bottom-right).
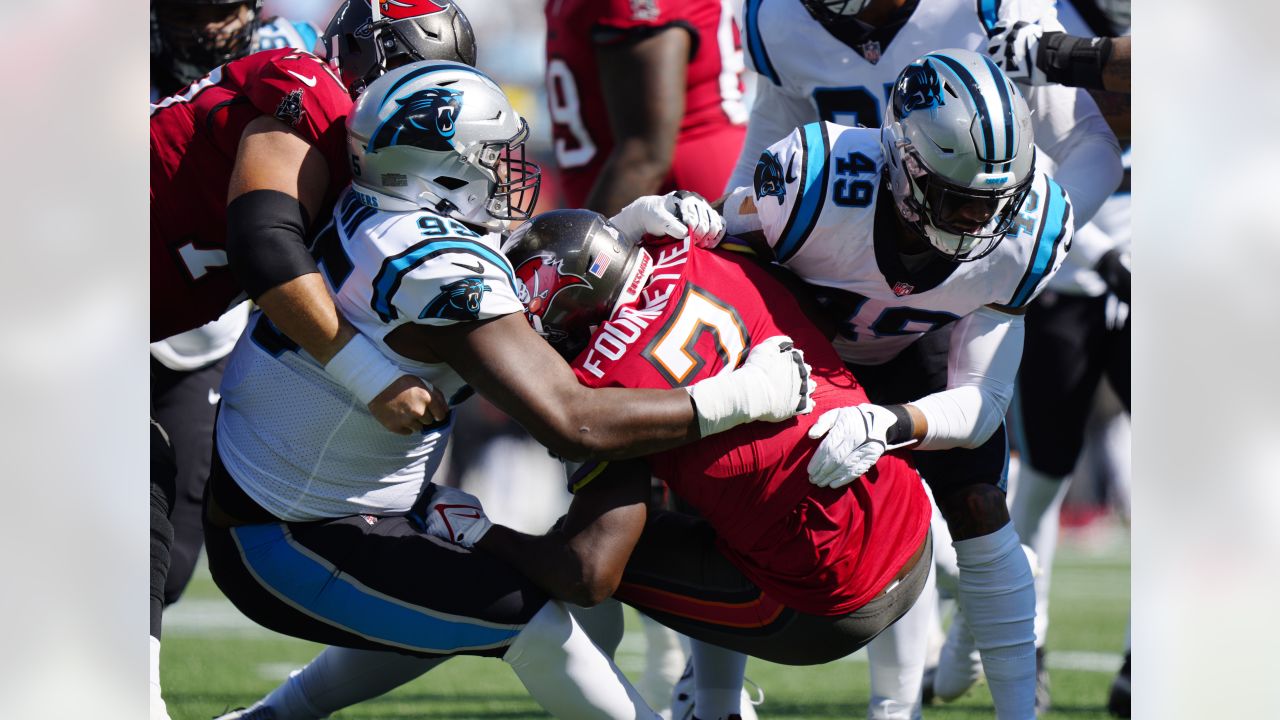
[{"x1": 613, "y1": 511, "x2": 933, "y2": 665}]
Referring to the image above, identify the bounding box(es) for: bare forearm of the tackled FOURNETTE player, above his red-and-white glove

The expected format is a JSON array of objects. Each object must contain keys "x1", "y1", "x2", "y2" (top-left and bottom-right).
[{"x1": 476, "y1": 525, "x2": 614, "y2": 607}]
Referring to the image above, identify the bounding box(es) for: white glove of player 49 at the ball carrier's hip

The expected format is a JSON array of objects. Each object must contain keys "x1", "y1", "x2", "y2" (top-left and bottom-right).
[{"x1": 809, "y1": 404, "x2": 915, "y2": 488}]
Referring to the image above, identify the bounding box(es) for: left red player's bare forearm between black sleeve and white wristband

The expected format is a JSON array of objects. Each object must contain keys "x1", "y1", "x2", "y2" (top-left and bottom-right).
[{"x1": 257, "y1": 273, "x2": 356, "y2": 365}]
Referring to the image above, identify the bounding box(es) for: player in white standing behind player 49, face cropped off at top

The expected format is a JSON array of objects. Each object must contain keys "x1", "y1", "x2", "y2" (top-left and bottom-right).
[{"x1": 727, "y1": 0, "x2": 1121, "y2": 717}]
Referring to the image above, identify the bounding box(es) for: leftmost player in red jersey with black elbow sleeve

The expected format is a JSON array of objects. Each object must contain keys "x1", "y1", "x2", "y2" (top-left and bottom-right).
[{"x1": 150, "y1": 0, "x2": 475, "y2": 717}]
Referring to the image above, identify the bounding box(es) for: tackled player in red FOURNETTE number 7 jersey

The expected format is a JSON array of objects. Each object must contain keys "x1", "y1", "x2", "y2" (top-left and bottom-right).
[{"x1": 417, "y1": 210, "x2": 932, "y2": 717}]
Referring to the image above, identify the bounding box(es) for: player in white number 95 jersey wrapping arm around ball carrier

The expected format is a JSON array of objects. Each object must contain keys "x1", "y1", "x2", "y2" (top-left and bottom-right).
[{"x1": 206, "y1": 61, "x2": 812, "y2": 719}]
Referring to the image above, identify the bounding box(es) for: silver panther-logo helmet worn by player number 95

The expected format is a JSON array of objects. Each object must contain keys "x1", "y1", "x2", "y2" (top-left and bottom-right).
[{"x1": 347, "y1": 60, "x2": 541, "y2": 231}]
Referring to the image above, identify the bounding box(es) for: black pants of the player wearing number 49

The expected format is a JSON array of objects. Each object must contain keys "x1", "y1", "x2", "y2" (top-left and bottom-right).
[{"x1": 845, "y1": 324, "x2": 1009, "y2": 502}]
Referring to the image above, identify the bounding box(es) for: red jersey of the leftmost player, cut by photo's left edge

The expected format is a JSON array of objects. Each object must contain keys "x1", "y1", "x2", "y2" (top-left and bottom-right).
[{"x1": 151, "y1": 47, "x2": 352, "y2": 341}]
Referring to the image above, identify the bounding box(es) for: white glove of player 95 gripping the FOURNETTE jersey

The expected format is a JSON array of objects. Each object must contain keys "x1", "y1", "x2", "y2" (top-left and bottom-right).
[{"x1": 686, "y1": 336, "x2": 814, "y2": 437}]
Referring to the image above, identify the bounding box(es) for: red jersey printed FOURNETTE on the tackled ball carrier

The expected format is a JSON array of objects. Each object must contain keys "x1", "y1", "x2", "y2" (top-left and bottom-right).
[{"x1": 573, "y1": 241, "x2": 931, "y2": 615}]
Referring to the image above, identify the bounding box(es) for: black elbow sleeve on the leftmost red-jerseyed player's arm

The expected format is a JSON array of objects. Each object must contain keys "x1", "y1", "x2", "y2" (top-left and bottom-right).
[{"x1": 227, "y1": 190, "x2": 317, "y2": 300}]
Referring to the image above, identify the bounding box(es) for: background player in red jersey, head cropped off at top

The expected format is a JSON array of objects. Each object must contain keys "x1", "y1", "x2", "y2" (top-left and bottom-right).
[{"x1": 547, "y1": 0, "x2": 746, "y2": 215}]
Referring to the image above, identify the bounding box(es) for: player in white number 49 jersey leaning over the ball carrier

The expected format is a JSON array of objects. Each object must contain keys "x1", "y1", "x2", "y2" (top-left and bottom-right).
[{"x1": 706, "y1": 49, "x2": 1073, "y2": 720}]
